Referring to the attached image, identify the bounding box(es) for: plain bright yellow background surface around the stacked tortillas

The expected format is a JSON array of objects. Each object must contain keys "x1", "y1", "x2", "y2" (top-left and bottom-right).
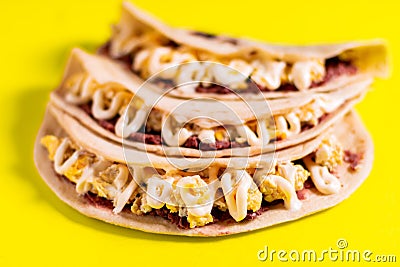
[{"x1": 0, "y1": 0, "x2": 400, "y2": 266}]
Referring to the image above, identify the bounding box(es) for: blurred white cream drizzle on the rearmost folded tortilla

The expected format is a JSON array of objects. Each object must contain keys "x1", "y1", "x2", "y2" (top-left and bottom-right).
[{"x1": 132, "y1": 46, "x2": 325, "y2": 90}]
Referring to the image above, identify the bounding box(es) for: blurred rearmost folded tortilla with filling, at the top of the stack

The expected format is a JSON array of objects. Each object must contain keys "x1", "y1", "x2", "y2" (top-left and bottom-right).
[{"x1": 99, "y1": 2, "x2": 388, "y2": 99}]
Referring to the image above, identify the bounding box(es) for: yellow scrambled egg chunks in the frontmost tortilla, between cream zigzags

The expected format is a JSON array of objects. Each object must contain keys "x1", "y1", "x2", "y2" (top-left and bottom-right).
[{"x1": 41, "y1": 135, "x2": 343, "y2": 228}]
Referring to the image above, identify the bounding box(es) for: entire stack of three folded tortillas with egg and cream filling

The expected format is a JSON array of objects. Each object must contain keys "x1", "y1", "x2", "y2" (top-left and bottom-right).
[{"x1": 34, "y1": 3, "x2": 388, "y2": 236}]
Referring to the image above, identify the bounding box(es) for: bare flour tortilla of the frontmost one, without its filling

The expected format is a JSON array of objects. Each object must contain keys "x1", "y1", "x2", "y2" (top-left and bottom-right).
[{"x1": 35, "y1": 107, "x2": 373, "y2": 236}]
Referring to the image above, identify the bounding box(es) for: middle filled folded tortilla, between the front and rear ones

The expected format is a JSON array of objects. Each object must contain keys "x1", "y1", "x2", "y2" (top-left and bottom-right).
[{"x1": 51, "y1": 49, "x2": 372, "y2": 157}]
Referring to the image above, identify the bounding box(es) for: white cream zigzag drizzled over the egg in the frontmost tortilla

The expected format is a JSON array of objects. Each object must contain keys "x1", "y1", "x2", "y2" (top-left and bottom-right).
[{"x1": 43, "y1": 134, "x2": 341, "y2": 226}]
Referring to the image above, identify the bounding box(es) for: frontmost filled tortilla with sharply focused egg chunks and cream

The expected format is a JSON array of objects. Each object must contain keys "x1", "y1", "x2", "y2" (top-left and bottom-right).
[{"x1": 35, "y1": 105, "x2": 373, "y2": 236}]
